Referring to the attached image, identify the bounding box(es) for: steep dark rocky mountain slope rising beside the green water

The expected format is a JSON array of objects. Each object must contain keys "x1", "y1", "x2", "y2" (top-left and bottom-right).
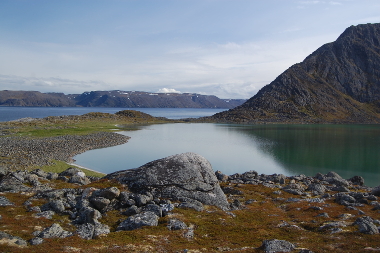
[{"x1": 211, "y1": 24, "x2": 380, "y2": 123}]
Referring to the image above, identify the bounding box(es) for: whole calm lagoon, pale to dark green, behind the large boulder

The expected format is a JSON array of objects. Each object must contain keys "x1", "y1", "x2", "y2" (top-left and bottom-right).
[{"x1": 75, "y1": 123, "x2": 380, "y2": 186}]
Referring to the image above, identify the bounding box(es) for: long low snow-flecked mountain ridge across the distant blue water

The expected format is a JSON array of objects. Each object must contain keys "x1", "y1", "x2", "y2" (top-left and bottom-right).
[{"x1": 0, "y1": 90, "x2": 246, "y2": 109}]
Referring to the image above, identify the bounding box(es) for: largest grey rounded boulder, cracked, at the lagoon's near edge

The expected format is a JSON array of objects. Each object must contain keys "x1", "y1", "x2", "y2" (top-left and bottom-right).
[{"x1": 105, "y1": 153, "x2": 228, "y2": 209}]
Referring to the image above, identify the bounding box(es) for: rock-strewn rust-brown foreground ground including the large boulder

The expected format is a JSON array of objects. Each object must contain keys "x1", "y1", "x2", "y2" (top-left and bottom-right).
[{"x1": 0, "y1": 153, "x2": 380, "y2": 253}]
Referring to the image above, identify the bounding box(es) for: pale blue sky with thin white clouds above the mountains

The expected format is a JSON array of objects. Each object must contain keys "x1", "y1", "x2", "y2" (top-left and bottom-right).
[{"x1": 0, "y1": 0, "x2": 380, "y2": 99}]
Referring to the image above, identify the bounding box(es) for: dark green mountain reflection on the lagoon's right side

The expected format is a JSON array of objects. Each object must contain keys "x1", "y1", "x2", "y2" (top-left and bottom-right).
[{"x1": 218, "y1": 125, "x2": 380, "y2": 186}]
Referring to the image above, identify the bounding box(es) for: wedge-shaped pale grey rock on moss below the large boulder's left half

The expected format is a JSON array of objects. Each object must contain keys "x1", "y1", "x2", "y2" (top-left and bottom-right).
[{"x1": 116, "y1": 212, "x2": 158, "y2": 231}]
